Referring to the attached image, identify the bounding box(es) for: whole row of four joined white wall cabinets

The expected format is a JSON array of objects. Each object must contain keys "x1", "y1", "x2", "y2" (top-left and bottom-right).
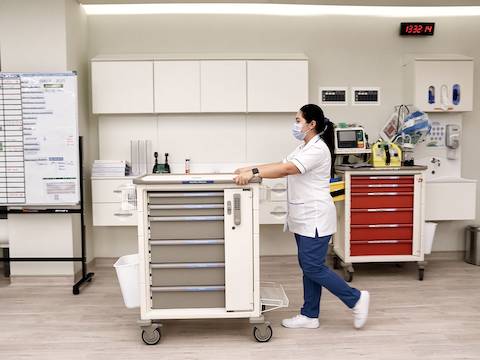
[{"x1": 91, "y1": 54, "x2": 308, "y2": 114}]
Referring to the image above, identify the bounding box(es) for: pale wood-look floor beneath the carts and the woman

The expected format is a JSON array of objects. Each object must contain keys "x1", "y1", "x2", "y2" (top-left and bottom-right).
[{"x1": 0, "y1": 257, "x2": 480, "y2": 360}]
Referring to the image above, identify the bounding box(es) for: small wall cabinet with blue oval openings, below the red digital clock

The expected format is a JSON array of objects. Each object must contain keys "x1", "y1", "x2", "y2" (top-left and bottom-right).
[{"x1": 404, "y1": 55, "x2": 473, "y2": 112}]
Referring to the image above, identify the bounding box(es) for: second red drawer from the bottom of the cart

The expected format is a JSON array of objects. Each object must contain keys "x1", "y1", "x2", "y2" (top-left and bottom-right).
[{"x1": 350, "y1": 224, "x2": 413, "y2": 242}]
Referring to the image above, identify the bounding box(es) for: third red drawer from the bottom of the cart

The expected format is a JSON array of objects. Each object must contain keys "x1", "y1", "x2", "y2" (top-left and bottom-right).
[{"x1": 350, "y1": 208, "x2": 413, "y2": 225}]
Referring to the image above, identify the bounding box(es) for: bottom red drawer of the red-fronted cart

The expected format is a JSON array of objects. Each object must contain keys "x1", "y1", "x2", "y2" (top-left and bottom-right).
[{"x1": 350, "y1": 240, "x2": 412, "y2": 256}]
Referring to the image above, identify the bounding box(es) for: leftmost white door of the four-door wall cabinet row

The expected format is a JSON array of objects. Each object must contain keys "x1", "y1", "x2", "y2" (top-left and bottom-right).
[{"x1": 92, "y1": 61, "x2": 153, "y2": 114}]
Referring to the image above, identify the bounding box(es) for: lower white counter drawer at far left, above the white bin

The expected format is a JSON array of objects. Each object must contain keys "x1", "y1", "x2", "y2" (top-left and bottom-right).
[{"x1": 92, "y1": 203, "x2": 138, "y2": 226}]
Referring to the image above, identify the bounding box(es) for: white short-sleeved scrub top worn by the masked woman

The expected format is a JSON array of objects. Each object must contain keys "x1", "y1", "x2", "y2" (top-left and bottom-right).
[{"x1": 283, "y1": 135, "x2": 337, "y2": 237}]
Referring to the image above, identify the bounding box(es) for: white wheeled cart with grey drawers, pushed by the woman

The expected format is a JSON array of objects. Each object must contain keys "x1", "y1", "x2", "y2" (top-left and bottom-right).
[{"x1": 134, "y1": 174, "x2": 288, "y2": 345}]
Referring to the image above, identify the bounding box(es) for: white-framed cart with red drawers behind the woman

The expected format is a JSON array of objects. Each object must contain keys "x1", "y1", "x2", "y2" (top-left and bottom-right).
[{"x1": 333, "y1": 166, "x2": 426, "y2": 282}]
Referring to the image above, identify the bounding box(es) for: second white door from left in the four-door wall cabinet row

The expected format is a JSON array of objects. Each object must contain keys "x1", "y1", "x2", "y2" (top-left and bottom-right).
[{"x1": 154, "y1": 61, "x2": 200, "y2": 113}]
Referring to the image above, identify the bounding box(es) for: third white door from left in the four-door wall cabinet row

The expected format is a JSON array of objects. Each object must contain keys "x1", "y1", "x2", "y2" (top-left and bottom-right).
[{"x1": 201, "y1": 60, "x2": 247, "y2": 112}]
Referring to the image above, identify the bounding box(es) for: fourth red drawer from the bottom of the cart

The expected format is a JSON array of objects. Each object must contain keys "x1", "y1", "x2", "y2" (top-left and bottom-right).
[{"x1": 350, "y1": 192, "x2": 413, "y2": 209}]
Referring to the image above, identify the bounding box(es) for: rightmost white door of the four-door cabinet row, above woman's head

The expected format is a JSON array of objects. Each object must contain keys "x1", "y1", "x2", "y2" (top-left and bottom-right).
[{"x1": 247, "y1": 60, "x2": 308, "y2": 112}]
